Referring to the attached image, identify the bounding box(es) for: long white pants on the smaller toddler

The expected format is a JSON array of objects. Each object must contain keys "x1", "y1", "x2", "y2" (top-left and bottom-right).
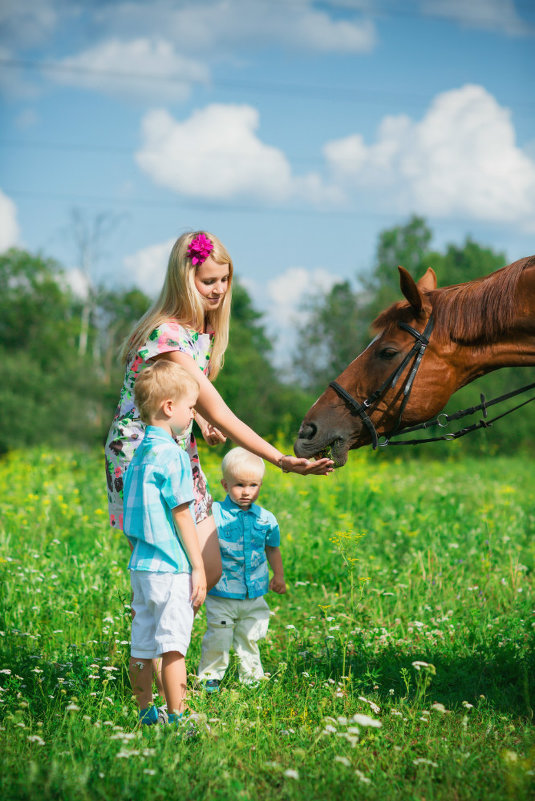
[{"x1": 199, "y1": 595, "x2": 269, "y2": 684}]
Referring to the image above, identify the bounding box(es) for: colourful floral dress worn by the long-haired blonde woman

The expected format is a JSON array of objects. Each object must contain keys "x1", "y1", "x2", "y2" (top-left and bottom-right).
[{"x1": 104, "y1": 321, "x2": 214, "y2": 529}]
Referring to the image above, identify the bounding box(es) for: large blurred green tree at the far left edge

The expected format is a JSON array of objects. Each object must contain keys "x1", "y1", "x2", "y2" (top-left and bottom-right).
[{"x1": 0, "y1": 249, "x2": 108, "y2": 452}]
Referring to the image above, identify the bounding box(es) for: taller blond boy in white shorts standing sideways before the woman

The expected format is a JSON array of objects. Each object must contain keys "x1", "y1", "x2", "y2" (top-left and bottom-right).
[{"x1": 124, "y1": 360, "x2": 206, "y2": 724}]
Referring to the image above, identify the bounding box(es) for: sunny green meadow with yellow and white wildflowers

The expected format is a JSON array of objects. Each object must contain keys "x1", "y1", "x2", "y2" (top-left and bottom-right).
[{"x1": 0, "y1": 447, "x2": 535, "y2": 801}]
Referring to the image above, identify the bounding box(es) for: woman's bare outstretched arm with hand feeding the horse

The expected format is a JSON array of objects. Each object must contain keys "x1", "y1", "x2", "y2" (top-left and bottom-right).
[{"x1": 156, "y1": 350, "x2": 333, "y2": 475}]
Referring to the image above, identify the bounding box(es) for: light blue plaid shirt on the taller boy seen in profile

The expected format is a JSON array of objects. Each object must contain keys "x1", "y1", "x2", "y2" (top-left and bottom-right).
[{"x1": 123, "y1": 426, "x2": 193, "y2": 573}]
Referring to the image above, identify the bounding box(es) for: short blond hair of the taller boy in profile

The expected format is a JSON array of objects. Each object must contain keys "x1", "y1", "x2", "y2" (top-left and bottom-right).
[{"x1": 134, "y1": 359, "x2": 199, "y2": 423}]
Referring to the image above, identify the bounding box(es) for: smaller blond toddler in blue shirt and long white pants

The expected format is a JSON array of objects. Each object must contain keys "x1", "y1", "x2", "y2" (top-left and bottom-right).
[{"x1": 199, "y1": 448, "x2": 286, "y2": 692}]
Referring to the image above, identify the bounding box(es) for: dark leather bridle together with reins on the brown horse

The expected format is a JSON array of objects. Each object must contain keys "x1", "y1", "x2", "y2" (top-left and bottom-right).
[{"x1": 329, "y1": 315, "x2": 535, "y2": 450}]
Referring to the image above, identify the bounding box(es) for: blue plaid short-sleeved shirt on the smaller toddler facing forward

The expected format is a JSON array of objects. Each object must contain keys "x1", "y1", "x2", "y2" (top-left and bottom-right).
[{"x1": 209, "y1": 495, "x2": 280, "y2": 598}]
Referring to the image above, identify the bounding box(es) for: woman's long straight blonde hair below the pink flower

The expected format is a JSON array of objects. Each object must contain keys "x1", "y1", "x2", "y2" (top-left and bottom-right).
[{"x1": 120, "y1": 231, "x2": 233, "y2": 381}]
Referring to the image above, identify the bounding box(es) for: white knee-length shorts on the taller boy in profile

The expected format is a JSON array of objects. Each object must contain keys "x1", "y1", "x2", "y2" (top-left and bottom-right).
[{"x1": 130, "y1": 570, "x2": 193, "y2": 659}]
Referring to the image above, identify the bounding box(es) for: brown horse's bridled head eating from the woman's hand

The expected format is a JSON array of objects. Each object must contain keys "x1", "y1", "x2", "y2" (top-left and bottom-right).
[{"x1": 294, "y1": 267, "x2": 456, "y2": 467}]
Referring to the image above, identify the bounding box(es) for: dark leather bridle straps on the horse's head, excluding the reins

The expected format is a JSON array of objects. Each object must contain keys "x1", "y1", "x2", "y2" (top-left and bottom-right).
[{"x1": 329, "y1": 315, "x2": 435, "y2": 450}]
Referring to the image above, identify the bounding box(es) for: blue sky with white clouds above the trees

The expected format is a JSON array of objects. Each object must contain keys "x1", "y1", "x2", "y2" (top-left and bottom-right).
[{"x1": 0, "y1": 0, "x2": 535, "y2": 366}]
